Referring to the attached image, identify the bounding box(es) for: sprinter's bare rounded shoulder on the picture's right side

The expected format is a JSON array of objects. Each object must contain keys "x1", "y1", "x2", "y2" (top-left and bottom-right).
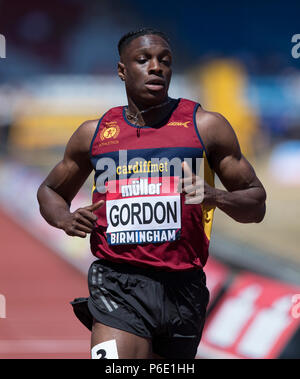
[{"x1": 196, "y1": 107, "x2": 239, "y2": 155}]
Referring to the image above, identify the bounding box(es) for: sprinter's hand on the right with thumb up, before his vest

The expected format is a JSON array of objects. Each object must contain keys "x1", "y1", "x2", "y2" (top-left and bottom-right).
[{"x1": 180, "y1": 162, "x2": 216, "y2": 206}]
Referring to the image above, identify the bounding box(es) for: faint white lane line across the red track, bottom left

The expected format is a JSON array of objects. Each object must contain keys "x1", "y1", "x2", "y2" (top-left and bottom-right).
[{"x1": 0, "y1": 340, "x2": 90, "y2": 358}]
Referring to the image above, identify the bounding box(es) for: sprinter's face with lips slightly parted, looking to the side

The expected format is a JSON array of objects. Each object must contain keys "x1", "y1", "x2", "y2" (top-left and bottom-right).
[{"x1": 118, "y1": 35, "x2": 172, "y2": 106}]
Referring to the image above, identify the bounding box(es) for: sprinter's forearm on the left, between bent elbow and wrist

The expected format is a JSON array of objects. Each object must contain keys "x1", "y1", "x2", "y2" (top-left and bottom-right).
[{"x1": 37, "y1": 184, "x2": 70, "y2": 229}]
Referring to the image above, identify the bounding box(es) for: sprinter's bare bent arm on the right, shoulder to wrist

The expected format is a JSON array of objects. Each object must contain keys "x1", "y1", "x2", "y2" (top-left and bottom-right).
[{"x1": 182, "y1": 109, "x2": 266, "y2": 223}]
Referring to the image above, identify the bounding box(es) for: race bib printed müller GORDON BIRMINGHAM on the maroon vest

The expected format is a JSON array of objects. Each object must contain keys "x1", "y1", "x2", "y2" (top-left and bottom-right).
[{"x1": 106, "y1": 177, "x2": 181, "y2": 245}]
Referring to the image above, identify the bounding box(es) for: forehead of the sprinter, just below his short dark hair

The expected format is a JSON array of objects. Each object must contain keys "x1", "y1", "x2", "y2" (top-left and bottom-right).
[{"x1": 124, "y1": 34, "x2": 171, "y2": 55}]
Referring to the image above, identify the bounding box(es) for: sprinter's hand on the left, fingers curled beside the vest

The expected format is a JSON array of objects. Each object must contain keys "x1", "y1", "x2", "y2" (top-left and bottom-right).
[{"x1": 60, "y1": 200, "x2": 104, "y2": 238}]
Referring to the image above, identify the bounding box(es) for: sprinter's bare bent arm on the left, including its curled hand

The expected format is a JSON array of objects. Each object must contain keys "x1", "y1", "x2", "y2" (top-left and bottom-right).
[{"x1": 37, "y1": 121, "x2": 101, "y2": 237}]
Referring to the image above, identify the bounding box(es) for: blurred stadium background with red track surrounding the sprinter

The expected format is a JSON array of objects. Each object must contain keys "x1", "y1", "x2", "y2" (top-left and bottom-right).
[{"x1": 0, "y1": 0, "x2": 300, "y2": 358}]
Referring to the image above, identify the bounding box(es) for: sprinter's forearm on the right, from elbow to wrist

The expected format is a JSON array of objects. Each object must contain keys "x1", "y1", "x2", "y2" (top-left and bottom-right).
[{"x1": 215, "y1": 187, "x2": 266, "y2": 223}]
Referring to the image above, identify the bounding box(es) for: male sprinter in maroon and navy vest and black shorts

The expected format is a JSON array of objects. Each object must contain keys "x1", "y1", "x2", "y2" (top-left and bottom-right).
[{"x1": 38, "y1": 29, "x2": 266, "y2": 359}]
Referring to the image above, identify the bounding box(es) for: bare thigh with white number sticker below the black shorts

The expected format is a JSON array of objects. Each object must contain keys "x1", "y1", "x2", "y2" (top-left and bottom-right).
[{"x1": 91, "y1": 321, "x2": 152, "y2": 359}]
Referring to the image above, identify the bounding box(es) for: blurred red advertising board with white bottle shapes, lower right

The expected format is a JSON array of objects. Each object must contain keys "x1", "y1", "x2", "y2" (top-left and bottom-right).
[{"x1": 197, "y1": 272, "x2": 300, "y2": 359}]
